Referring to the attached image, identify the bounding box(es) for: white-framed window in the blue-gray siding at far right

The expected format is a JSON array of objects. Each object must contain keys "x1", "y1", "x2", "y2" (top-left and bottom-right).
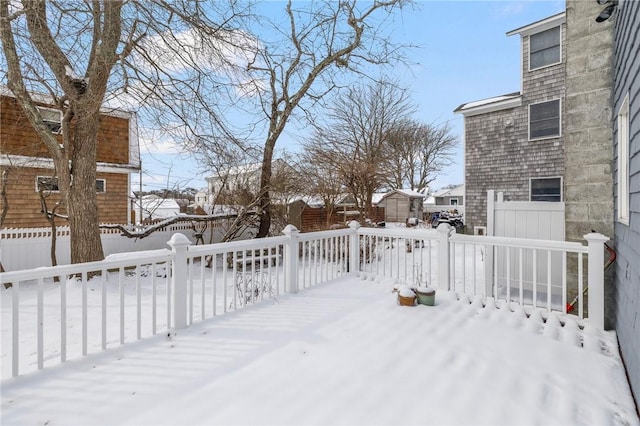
[{"x1": 616, "y1": 94, "x2": 629, "y2": 225}]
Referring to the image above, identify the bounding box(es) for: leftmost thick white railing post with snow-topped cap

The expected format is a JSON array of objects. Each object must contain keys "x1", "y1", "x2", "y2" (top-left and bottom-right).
[{"x1": 167, "y1": 232, "x2": 191, "y2": 330}]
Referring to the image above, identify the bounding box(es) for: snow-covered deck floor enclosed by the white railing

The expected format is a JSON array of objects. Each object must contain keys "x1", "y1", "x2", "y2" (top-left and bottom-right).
[{"x1": 0, "y1": 278, "x2": 640, "y2": 425}]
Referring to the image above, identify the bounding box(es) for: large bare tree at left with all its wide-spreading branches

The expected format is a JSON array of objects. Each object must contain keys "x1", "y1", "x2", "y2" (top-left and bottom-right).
[{"x1": 0, "y1": 0, "x2": 248, "y2": 263}]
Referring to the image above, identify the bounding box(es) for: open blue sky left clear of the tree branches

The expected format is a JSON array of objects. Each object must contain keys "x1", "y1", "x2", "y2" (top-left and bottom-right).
[{"x1": 132, "y1": 0, "x2": 565, "y2": 190}]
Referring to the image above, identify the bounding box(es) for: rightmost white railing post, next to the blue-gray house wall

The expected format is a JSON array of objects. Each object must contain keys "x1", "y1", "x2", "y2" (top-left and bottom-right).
[{"x1": 584, "y1": 232, "x2": 609, "y2": 330}]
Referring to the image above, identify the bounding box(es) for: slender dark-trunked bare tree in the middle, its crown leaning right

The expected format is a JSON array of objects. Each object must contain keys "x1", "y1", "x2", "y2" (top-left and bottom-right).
[{"x1": 248, "y1": 0, "x2": 408, "y2": 237}]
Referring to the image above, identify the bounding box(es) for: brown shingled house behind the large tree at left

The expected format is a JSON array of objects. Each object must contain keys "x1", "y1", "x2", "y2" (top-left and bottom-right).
[{"x1": 0, "y1": 87, "x2": 140, "y2": 228}]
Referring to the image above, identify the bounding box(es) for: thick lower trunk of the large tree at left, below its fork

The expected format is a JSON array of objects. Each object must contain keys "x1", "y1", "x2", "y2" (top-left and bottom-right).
[{"x1": 66, "y1": 110, "x2": 104, "y2": 263}]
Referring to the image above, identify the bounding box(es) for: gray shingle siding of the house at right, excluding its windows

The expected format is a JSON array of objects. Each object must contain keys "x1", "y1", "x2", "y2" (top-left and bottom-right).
[{"x1": 465, "y1": 25, "x2": 565, "y2": 233}]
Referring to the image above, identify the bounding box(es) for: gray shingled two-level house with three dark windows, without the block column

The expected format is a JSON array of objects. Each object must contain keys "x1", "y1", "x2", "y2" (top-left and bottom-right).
[{"x1": 455, "y1": 12, "x2": 566, "y2": 236}]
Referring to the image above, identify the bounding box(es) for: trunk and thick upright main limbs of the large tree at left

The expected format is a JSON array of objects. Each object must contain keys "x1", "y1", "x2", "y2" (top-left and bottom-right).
[{"x1": 0, "y1": 0, "x2": 135, "y2": 262}]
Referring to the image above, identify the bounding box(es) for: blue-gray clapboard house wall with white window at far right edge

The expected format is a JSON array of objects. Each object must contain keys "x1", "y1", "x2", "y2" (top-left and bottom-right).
[{"x1": 611, "y1": 1, "x2": 640, "y2": 404}]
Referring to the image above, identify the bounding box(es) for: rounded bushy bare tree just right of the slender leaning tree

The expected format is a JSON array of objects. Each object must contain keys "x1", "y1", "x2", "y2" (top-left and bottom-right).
[{"x1": 307, "y1": 80, "x2": 414, "y2": 217}]
